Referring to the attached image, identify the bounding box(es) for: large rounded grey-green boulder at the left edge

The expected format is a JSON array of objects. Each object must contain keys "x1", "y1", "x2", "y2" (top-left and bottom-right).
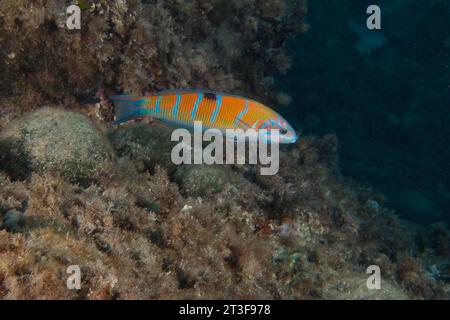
[{"x1": 0, "y1": 107, "x2": 114, "y2": 184}]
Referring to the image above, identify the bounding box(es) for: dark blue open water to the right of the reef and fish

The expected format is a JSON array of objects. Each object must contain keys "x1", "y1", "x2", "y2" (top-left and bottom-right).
[{"x1": 278, "y1": 0, "x2": 450, "y2": 224}]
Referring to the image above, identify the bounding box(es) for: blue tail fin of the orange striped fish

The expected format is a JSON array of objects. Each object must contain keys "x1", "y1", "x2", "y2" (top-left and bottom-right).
[{"x1": 109, "y1": 95, "x2": 149, "y2": 124}]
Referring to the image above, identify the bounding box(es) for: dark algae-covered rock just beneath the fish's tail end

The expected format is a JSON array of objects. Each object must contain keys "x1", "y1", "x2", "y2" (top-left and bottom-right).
[{"x1": 109, "y1": 124, "x2": 177, "y2": 174}]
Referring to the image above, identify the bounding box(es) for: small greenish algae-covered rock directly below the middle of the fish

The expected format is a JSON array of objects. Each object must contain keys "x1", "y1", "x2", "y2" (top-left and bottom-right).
[{"x1": 174, "y1": 165, "x2": 248, "y2": 197}]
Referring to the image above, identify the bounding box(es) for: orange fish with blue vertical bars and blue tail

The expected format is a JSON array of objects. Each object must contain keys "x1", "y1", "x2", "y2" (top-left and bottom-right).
[{"x1": 110, "y1": 89, "x2": 298, "y2": 144}]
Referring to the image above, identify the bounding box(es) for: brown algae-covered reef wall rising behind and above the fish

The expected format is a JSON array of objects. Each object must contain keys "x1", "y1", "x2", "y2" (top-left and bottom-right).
[{"x1": 0, "y1": 0, "x2": 305, "y2": 110}]
